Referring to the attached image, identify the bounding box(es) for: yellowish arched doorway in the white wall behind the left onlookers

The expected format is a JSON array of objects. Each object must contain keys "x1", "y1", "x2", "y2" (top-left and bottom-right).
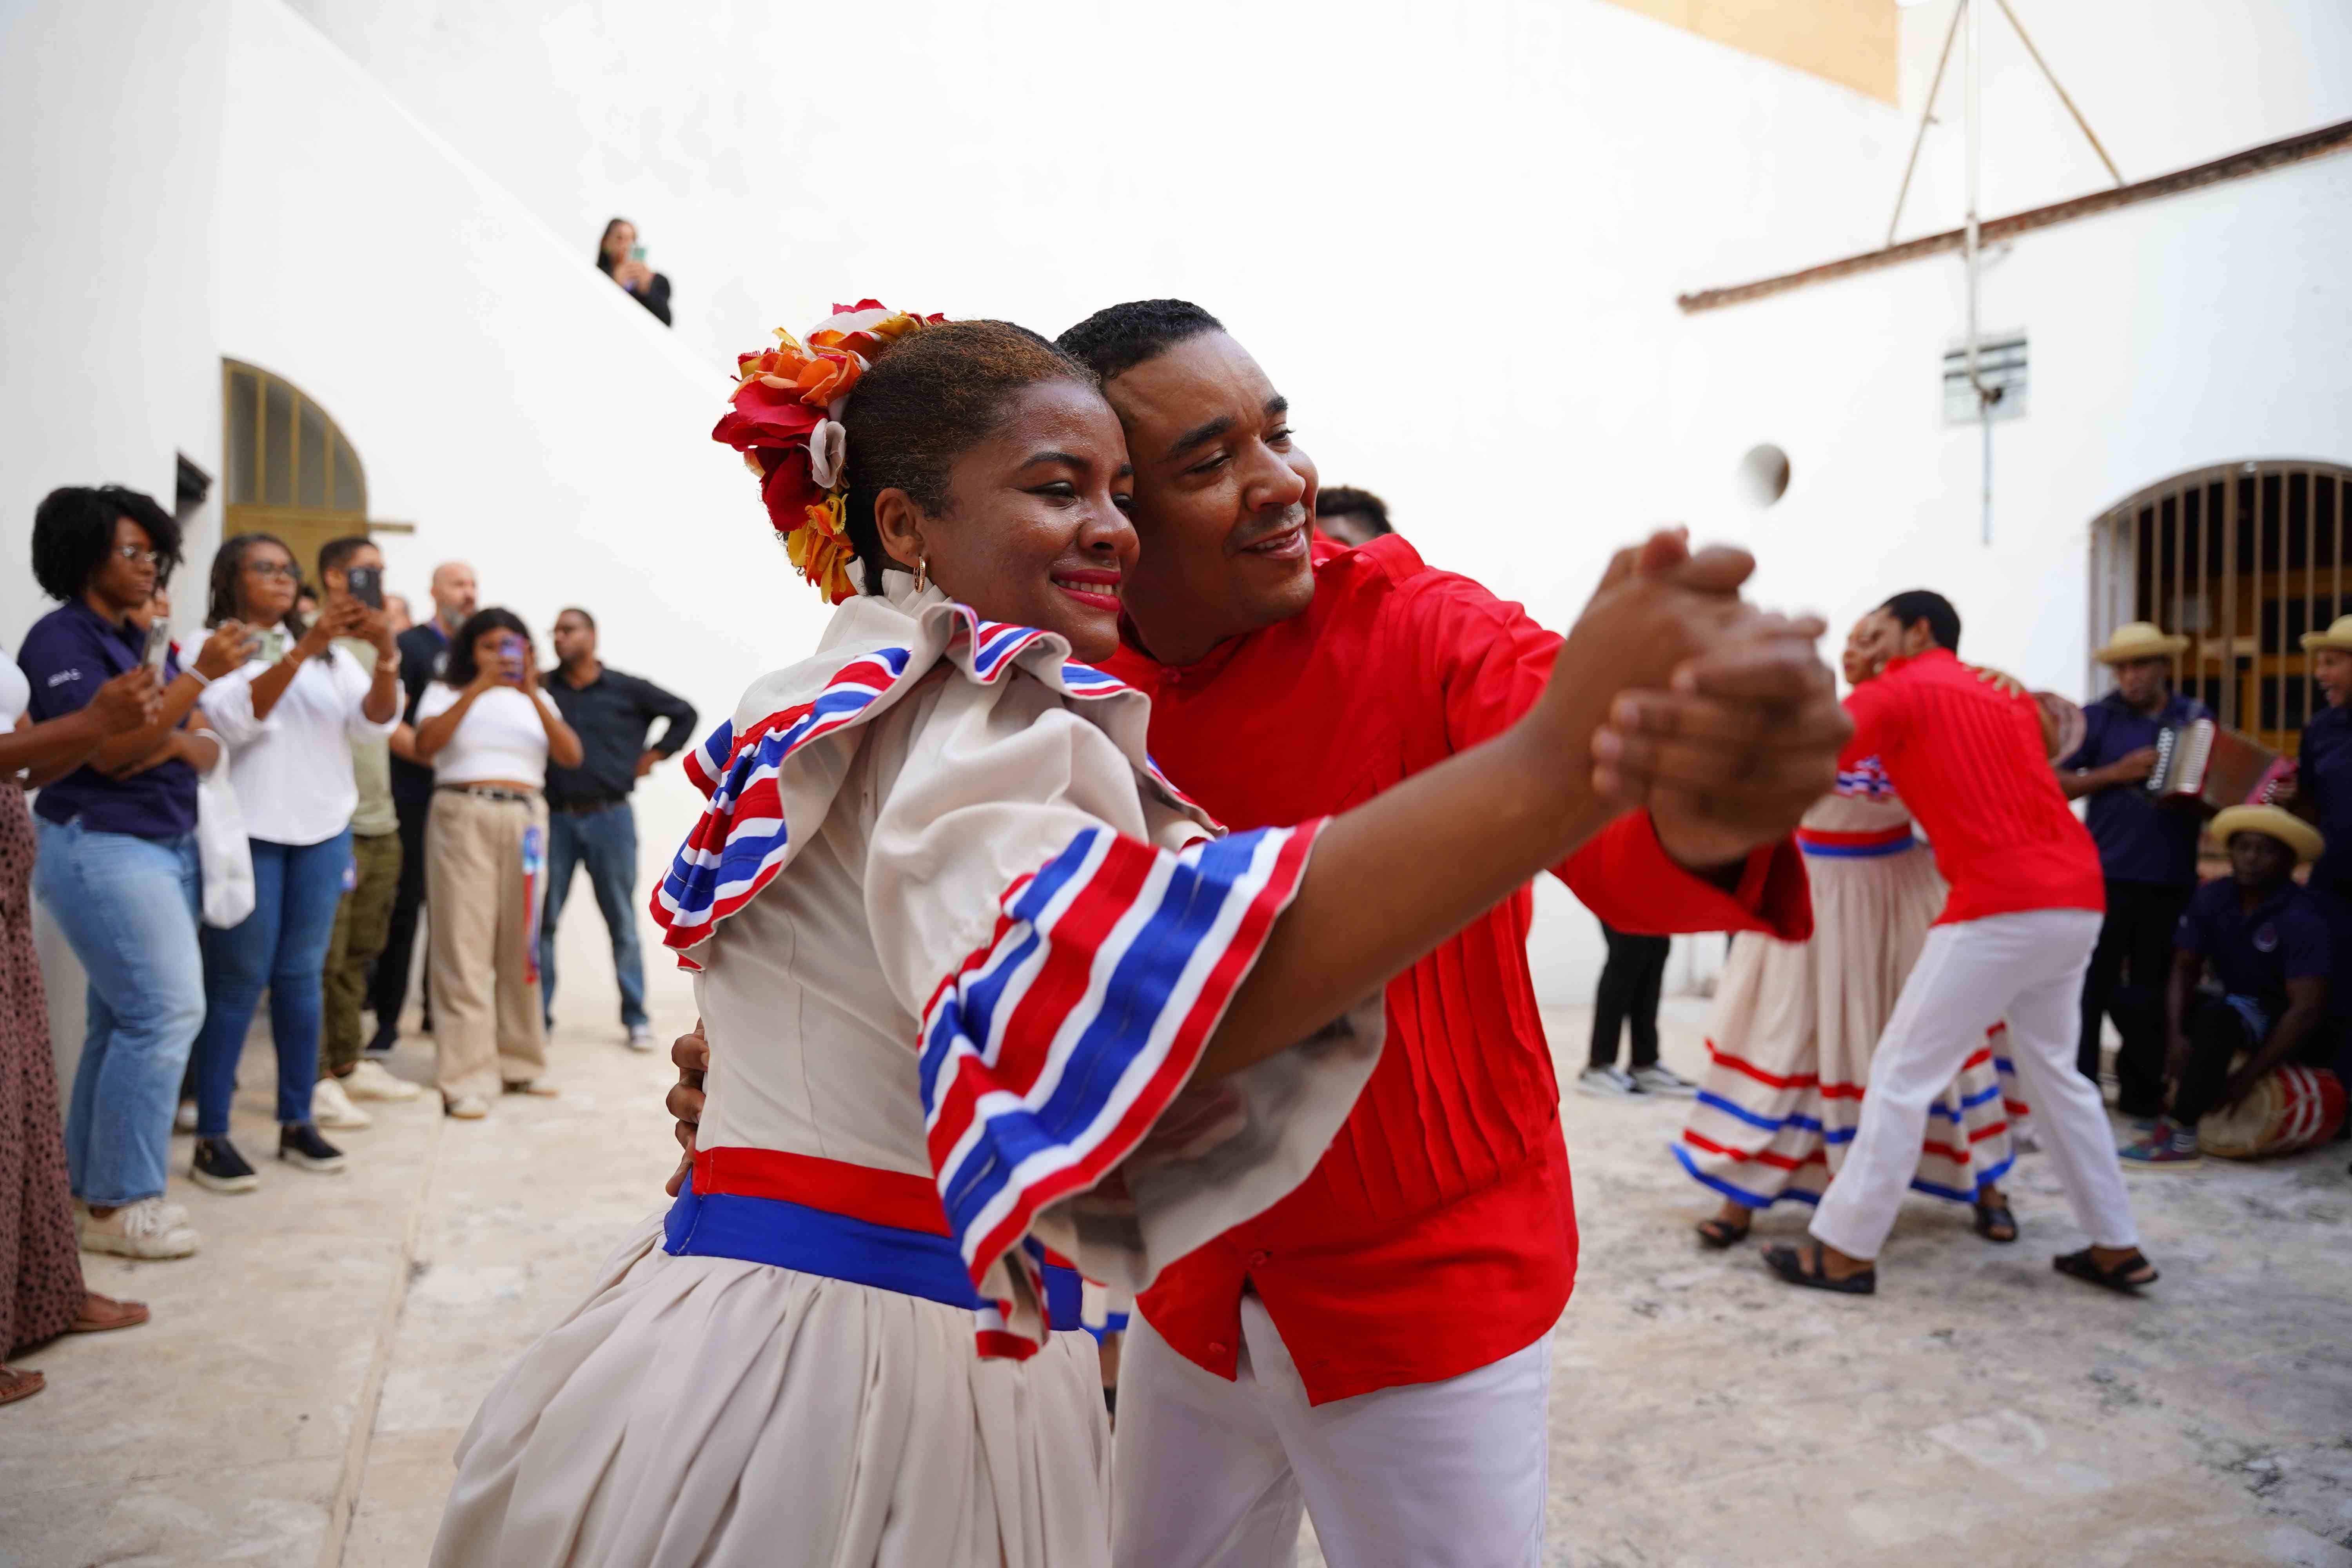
[{"x1": 221, "y1": 360, "x2": 367, "y2": 590}]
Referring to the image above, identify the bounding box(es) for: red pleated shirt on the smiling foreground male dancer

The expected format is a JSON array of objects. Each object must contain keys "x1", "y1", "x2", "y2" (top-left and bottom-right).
[{"x1": 1110, "y1": 536, "x2": 1813, "y2": 1403}]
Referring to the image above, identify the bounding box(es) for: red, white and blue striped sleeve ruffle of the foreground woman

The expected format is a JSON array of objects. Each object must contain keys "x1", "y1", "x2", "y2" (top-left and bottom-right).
[{"x1": 920, "y1": 820, "x2": 1322, "y2": 1283}]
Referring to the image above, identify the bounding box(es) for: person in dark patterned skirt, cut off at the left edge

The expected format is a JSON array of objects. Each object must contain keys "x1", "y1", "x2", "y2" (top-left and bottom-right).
[{"x1": 0, "y1": 653, "x2": 155, "y2": 1406}]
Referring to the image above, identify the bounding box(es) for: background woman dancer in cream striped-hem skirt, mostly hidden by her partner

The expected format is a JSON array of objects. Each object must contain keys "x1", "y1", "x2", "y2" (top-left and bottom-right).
[{"x1": 1672, "y1": 628, "x2": 2025, "y2": 1246}]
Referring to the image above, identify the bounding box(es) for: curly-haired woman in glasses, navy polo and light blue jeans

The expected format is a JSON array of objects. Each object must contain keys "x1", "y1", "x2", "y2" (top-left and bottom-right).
[{"x1": 16, "y1": 484, "x2": 247, "y2": 1258}]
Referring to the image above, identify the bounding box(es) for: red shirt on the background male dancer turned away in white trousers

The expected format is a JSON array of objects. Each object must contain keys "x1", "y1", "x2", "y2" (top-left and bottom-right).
[{"x1": 1844, "y1": 649, "x2": 2107, "y2": 926}]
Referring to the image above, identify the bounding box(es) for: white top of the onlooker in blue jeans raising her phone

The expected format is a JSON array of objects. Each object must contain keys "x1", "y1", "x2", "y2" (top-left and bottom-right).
[{"x1": 195, "y1": 651, "x2": 400, "y2": 844}]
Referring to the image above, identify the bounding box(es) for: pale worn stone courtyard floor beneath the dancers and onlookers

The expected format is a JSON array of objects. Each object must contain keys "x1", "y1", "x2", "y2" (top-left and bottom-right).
[{"x1": 0, "y1": 1001, "x2": 2352, "y2": 1568}]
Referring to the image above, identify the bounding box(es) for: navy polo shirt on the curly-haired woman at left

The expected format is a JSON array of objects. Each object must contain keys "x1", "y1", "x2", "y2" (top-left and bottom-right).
[{"x1": 16, "y1": 599, "x2": 195, "y2": 839}]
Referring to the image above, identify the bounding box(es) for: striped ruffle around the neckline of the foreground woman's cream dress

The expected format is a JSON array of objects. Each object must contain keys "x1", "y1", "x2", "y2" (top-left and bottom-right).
[{"x1": 652, "y1": 599, "x2": 1216, "y2": 969}]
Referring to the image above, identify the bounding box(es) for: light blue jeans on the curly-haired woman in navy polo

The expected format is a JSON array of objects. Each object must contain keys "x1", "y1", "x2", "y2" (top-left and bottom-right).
[{"x1": 33, "y1": 818, "x2": 205, "y2": 1208}]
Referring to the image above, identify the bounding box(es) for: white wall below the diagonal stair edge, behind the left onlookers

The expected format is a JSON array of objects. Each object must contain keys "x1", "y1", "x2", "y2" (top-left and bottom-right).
[{"x1": 219, "y1": 0, "x2": 823, "y2": 973}]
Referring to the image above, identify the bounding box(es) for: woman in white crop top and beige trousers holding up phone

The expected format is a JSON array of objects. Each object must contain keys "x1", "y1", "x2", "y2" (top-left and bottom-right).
[{"x1": 416, "y1": 609, "x2": 581, "y2": 1122}]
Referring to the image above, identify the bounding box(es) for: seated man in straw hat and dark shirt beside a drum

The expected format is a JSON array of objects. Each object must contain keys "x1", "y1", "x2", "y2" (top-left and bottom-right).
[{"x1": 2122, "y1": 806, "x2": 2336, "y2": 1171}]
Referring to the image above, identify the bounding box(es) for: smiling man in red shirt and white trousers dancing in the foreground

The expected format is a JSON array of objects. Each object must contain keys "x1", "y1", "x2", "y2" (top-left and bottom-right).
[{"x1": 1061, "y1": 301, "x2": 1844, "y2": 1568}]
